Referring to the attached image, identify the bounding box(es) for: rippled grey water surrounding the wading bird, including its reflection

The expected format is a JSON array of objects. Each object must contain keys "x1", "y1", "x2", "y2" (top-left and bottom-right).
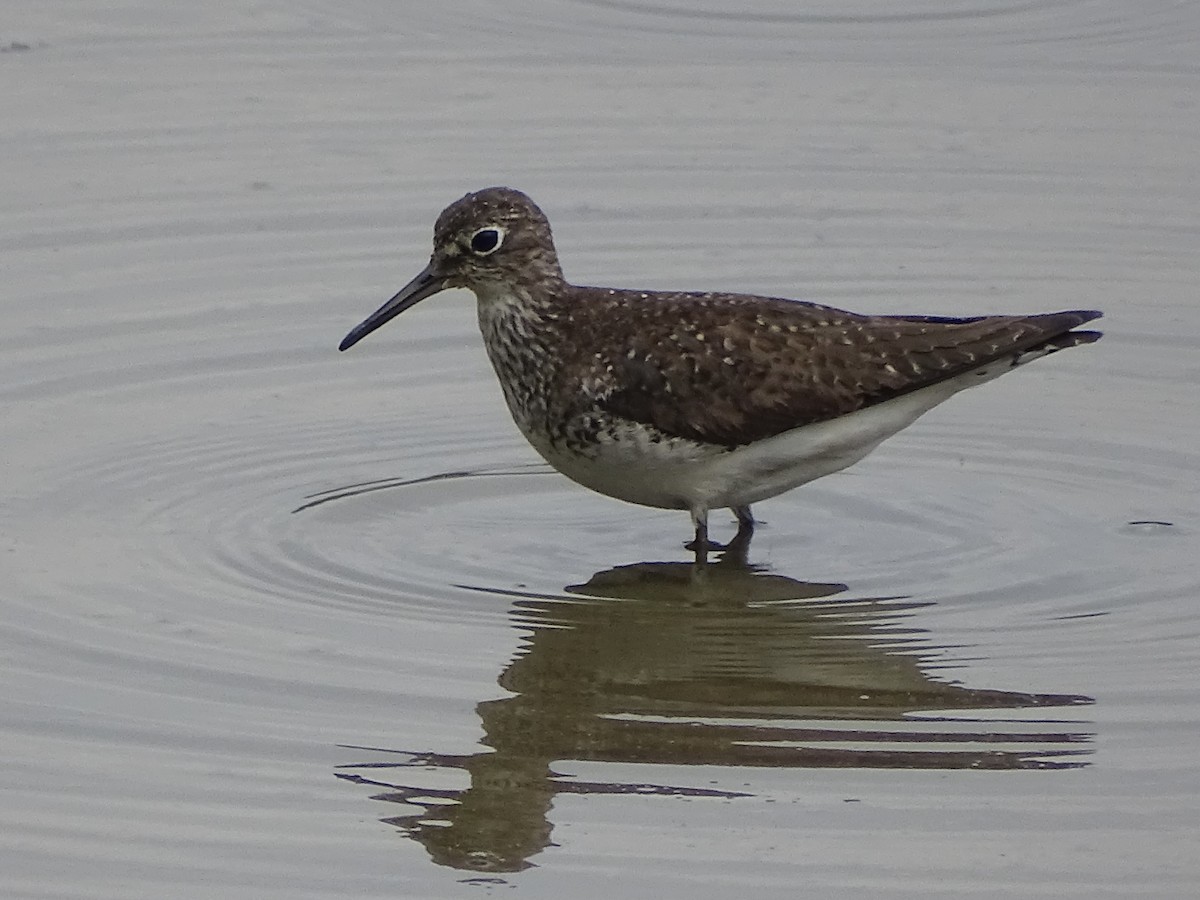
[{"x1": 0, "y1": 0, "x2": 1200, "y2": 898}]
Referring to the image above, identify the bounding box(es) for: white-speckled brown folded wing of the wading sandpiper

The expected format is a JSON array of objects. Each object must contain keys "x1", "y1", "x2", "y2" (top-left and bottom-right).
[{"x1": 585, "y1": 294, "x2": 1100, "y2": 446}]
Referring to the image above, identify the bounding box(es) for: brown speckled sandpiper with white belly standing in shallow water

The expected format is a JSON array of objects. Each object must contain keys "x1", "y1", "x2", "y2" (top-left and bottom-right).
[{"x1": 338, "y1": 187, "x2": 1100, "y2": 562}]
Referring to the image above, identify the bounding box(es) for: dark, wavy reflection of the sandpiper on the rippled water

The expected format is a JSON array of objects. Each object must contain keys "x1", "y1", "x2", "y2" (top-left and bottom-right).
[{"x1": 340, "y1": 559, "x2": 1092, "y2": 871}]
